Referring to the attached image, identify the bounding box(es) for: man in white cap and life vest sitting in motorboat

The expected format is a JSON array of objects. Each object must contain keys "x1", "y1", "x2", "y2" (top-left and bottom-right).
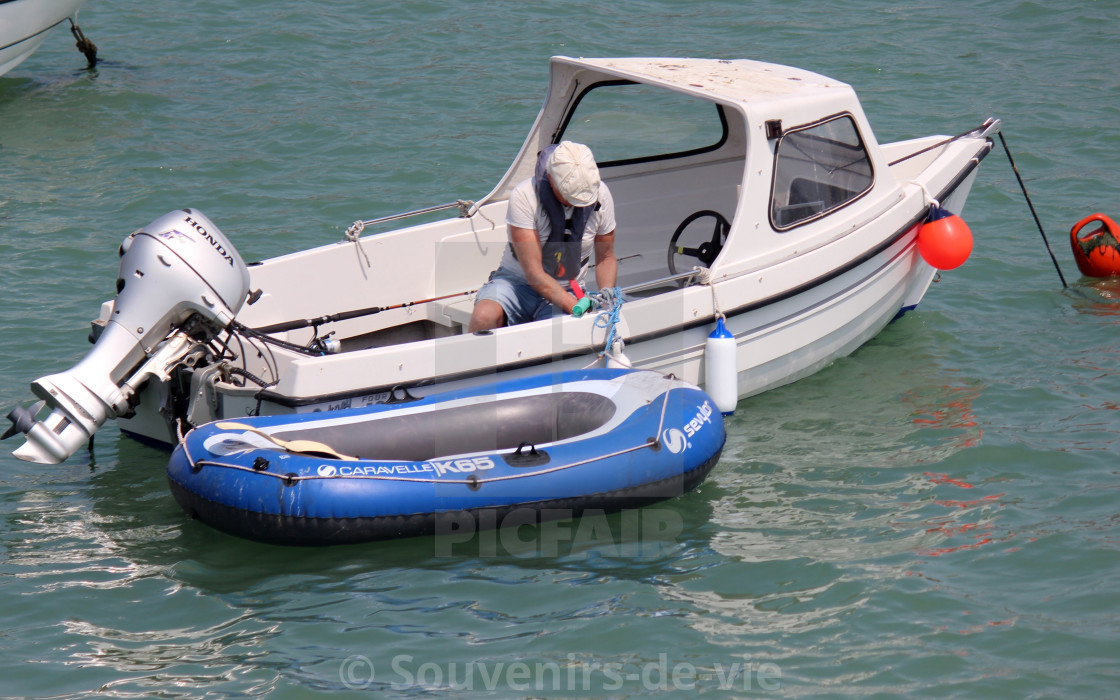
[{"x1": 469, "y1": 141, "x2": 618, "y2": 333}]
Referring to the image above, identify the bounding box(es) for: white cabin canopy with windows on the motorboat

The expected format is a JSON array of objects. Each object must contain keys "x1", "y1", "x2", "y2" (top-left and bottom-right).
[{"x1": 480, "y1": 56, "x2": 898, "y2": 284}]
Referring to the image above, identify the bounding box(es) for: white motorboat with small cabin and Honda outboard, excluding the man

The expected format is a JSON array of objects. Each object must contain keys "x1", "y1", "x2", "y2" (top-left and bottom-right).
[{"x1": 0, "y1": 57, "x2": 999, "y2": 463}]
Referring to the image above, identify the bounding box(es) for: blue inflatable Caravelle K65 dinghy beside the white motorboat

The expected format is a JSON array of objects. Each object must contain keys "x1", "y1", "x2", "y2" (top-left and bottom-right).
[{"x1": 167, "y1": 370, "x2": 726, "y2": 544}]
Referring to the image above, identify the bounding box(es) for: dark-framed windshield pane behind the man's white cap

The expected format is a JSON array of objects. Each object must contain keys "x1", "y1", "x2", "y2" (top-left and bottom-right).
[{"x1": 556, "y1": 81, "x2": 727, "y2": 167}]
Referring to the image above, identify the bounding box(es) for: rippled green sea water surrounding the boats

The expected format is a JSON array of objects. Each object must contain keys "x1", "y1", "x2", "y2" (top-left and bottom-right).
[{"x1": 0, "y1": 0, "x2": 1120, "y2": 699}]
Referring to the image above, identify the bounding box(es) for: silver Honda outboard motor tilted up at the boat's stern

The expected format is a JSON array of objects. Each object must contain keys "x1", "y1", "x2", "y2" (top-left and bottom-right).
[{"x1": 3, "y1": 209, "x2": 249, "y2": 464}]
